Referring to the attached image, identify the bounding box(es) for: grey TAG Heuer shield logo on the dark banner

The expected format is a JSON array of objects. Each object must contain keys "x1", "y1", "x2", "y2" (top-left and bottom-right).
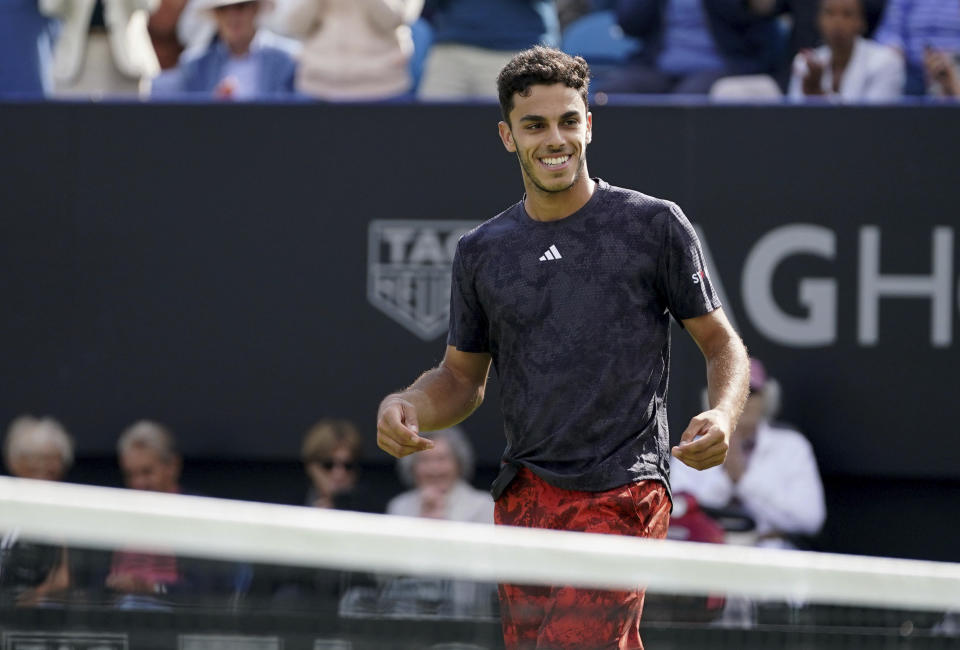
[{"x1": 367, "y1": 219, "x2": 477, "y2": 341}]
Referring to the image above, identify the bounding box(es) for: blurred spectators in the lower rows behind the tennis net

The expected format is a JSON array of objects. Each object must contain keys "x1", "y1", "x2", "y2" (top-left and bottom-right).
[{"x1": 0, "y1": 360, "x2": 825, "y2": 618}]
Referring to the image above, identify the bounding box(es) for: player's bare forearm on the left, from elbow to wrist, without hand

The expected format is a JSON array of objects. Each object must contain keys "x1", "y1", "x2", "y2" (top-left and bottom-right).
[{"x1": 384, "y1": 363, "x2": 484, "y2": 431}]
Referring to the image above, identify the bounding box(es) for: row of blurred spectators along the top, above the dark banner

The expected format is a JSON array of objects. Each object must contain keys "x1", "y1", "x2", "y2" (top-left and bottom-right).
[{"x1": 0, "y1": 0, "x2": 960, "y2": 103}]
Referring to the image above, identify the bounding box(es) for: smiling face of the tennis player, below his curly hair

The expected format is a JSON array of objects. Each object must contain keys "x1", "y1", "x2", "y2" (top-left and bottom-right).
[{"x1": 500, "y1": 84, "x2": 592, "y2": 193}]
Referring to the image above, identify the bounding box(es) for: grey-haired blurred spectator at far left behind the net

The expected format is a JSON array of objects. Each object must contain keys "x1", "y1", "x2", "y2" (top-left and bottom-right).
[{"x1": 0, "y1": 415, "x2": 73, "y2": 607}]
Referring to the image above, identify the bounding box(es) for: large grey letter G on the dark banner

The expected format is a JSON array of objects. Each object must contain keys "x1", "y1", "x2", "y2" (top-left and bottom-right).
[{"x1": 741, "y1": 224, "x2": 837, "y2": 347}]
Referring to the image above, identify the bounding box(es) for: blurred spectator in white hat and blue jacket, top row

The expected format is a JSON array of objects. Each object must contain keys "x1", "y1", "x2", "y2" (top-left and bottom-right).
[{"x1": 152, "y1": 0, "x2": 296, "y2": 100}]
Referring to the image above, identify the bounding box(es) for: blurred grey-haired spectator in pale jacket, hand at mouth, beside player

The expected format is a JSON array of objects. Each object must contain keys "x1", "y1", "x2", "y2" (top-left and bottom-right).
[{"x1": 387, "y1": 427, "x2": 493, "y2": 524}]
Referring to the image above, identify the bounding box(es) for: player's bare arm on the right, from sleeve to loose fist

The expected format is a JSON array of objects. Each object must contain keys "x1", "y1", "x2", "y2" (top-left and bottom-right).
[{"x1": 671, "y1": 309, "x2": 750, "y2": 469}]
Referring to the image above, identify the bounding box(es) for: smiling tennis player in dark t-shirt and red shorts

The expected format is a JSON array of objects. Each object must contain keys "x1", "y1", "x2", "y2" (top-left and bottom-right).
[{"x1": 377, "y1": 47, "x2": 749, "y2": 648}]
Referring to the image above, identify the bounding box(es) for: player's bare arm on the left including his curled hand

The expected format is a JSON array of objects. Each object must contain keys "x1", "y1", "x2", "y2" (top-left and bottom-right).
[{"x1": 377, "y1": 345, "x2": 490, "y2": 458}]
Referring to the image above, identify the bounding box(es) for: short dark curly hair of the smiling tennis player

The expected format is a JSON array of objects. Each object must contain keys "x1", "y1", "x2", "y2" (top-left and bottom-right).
[{"x1": 497, "y1": 45, "x2": 590, "y2": 124}]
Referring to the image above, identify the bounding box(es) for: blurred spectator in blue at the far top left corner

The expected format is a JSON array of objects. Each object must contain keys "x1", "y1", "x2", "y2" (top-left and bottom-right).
[{"x1": 0, "y1": 0, "x2": 55, "y2": 97}]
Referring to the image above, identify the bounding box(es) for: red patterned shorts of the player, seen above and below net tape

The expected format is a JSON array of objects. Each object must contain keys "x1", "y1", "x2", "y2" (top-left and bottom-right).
[{"x1": 494, "y1": 468, "x2": 670, "y2": 650}]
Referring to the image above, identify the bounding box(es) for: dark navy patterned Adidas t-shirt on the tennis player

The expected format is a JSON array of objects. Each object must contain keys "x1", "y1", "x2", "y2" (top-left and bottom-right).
[{"x1": 448, "y1": 180, "x2": 720, "y2": 498}]
